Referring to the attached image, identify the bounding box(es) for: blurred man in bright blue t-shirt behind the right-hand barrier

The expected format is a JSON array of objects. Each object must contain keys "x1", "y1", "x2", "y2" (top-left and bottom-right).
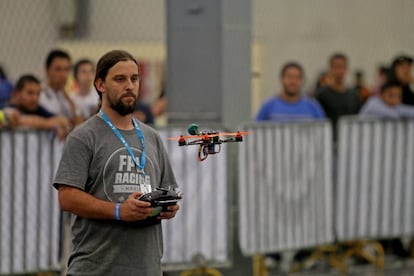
[{"x1": 256, "y1": 62, "x2": 325, "y2": 122}]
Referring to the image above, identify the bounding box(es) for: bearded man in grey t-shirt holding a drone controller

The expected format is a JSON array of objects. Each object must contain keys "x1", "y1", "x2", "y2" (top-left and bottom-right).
[{"x1": 53, "y1": 50, "x2": 179, "y2": 276}]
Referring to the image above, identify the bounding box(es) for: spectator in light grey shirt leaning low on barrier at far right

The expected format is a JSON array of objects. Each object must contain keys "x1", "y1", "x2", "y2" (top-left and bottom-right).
[{"x1": 359, "y1": 82, "x2": 414, "y2": 119}]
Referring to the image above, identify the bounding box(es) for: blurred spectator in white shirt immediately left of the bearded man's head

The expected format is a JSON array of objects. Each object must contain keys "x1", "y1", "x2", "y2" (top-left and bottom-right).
[{"x1": 70, "y1": 59, "x2": 99, "y2": 119}]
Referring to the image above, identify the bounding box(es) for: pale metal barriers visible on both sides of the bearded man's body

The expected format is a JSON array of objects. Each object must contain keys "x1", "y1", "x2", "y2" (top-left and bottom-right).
[{"x1": 0, "y1": 129, "x2": 229, "y2": 274}]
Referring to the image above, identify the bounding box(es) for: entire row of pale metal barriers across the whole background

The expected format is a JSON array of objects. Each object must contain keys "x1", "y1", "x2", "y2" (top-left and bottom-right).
[{"x1": 0, "y1": 118, "x2": 414, "y2": 274}]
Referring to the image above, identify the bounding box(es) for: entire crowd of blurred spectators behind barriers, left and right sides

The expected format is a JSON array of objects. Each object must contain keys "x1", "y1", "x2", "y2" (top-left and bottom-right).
[{"x1": 0, "y1": 49, "x2": 414, "y2": 140}]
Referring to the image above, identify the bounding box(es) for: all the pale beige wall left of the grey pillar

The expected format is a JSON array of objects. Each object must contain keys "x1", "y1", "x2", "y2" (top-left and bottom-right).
[{"x1": 0, "y1": 0, "x2": 165, "y2": 80}]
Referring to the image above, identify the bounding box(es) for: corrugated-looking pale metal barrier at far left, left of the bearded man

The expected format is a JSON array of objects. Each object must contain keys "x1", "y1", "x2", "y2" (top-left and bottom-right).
[{"x1": 0, "y1": 131, "x2": 61, "y2": 275}]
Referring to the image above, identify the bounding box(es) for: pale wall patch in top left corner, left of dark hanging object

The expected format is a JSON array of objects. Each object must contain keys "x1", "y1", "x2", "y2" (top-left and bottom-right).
[{"x1": 0, "y1": 0, "x2": 58, "y2": 80}]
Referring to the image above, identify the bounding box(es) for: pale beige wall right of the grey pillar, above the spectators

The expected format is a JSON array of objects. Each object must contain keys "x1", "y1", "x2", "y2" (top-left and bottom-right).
[{"x1": 252, "y1": 0, "x2": 414, "y2": 102}]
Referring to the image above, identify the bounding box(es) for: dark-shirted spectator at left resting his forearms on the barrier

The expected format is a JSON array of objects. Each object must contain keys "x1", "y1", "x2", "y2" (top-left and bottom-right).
[{"x1": 10, "y1": 75, "x2": 70, "y2": 139}]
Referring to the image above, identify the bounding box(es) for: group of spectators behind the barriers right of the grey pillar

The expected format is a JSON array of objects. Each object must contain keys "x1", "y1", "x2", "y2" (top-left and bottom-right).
[{"x1": 256, "y1": 53, "x2": 414, "y2": 140}]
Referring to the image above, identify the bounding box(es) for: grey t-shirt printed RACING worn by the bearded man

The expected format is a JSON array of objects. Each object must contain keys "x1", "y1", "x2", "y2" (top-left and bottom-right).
[{"x1": 53, "y1": 116, "x2": 177, "y2": 276}]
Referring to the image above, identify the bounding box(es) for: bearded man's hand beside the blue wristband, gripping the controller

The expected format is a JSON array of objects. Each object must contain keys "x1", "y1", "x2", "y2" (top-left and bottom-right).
[{"x1": 120, "y1": 192, "x2": 154, "y2": 221}]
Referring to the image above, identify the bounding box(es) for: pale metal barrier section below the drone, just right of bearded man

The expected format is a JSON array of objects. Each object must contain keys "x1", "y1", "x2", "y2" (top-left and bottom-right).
[{"x1": 159, "y1": 129, "x2": 230, "y2": 266}]
